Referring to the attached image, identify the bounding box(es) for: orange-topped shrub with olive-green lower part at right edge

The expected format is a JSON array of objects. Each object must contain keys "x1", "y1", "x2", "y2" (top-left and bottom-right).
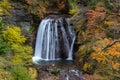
[{"x1": 91, "y1": 38, "x2": 120, "y2": 80}]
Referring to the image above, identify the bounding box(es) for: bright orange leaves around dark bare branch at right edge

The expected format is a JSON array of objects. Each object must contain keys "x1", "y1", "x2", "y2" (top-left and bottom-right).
[{"x1": 91, "y1": 38, "x2": 120, "y2": 69}]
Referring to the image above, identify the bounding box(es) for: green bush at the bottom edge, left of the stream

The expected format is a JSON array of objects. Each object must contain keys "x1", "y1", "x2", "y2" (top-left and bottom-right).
[{"x1": 11, "y1": 65, "x2": 32, "y2": 80}]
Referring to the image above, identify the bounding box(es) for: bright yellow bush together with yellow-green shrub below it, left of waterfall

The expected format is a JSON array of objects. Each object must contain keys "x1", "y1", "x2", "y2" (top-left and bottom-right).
[{"x1": 3, "y1": 26, "x2": 33, "y2": 65}]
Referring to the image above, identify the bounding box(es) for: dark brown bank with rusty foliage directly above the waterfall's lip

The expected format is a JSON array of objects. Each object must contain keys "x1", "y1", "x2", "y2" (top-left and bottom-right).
[{"x1": 25, "y1": 0, "x2": 69, "y2": 19}]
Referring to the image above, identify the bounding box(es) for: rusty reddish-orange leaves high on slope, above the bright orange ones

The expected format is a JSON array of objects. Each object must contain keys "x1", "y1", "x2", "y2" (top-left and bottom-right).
[{"x1": 85, "y1": 7, "x2": 106, "y2": 40}]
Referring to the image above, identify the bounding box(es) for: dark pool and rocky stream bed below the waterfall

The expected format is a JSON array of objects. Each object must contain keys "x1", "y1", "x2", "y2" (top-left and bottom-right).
[{"x1": 34, "y1": 60, "x2": 86, "y2": 80}]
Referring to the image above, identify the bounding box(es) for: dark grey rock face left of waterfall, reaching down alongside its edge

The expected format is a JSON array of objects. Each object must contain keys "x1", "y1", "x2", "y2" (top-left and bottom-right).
[{"x1": 2, "y1": 0, "x2": 40, "y2": 47}]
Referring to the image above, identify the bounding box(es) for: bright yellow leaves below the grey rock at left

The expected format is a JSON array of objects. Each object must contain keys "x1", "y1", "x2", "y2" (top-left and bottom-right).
[{"x1": 3, "y1": 26, "x2": 26, "y2": 46}]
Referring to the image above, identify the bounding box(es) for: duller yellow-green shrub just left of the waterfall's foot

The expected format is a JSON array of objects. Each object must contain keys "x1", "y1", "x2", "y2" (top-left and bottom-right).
[{"x1": 11, "y1": 44, "x2": 32, "y2": 66}]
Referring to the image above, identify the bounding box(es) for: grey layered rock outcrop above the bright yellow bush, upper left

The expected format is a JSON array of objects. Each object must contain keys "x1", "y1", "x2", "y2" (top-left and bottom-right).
[{"x1": 3, "y1": 2, "x2": 37, "y2": 30}]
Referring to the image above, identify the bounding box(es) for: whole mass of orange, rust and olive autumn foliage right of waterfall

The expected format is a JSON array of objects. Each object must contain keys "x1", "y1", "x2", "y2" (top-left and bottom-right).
[{"x1": 75, "y1": 0, "x2": 120, "y2": 80}]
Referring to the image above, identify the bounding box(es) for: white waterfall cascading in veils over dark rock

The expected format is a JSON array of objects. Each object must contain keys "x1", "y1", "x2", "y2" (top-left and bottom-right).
[{"x1": 32, "y1": 18, "x2": 75, "y2": 62}]
